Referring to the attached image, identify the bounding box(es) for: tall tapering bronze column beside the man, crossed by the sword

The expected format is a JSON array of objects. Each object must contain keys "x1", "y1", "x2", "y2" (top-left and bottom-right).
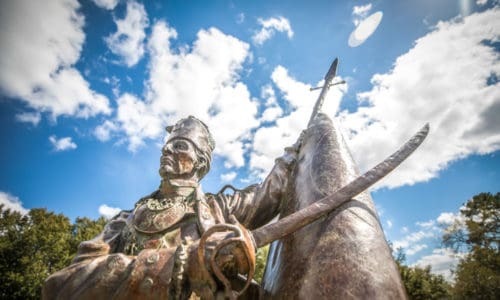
[{"x1": 263, "y1": 115, "x2": 406, "y2": 299}]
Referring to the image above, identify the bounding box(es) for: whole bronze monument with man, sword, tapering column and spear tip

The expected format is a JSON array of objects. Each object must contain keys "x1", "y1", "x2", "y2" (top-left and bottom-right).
[{"x1": 43, "y1": 60, "x2": 428, "y2": 299}]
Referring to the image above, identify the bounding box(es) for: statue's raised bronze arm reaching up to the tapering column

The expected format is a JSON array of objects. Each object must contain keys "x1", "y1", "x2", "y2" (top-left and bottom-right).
[{"x1": 215, "y1": 147, "x2": 297, "y2": 230}]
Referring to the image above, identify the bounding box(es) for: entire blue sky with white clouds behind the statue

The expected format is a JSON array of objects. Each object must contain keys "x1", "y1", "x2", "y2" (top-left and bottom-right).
[{"x1": 0, "y1": 0, "x2": 500, "y2": 282}]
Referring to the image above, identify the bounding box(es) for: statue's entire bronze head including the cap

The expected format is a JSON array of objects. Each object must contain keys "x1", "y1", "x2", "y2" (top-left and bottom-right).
[{"x1": 160, "y1": 116, "x2": 215, "y2": 179}]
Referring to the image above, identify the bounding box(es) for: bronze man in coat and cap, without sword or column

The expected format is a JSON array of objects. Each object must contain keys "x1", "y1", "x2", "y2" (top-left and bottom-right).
[{"x1": 43, "y1": 116, "x2": 296, "y2": 300}]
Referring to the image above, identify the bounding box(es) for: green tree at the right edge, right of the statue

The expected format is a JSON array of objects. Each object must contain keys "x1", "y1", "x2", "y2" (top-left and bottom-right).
[{"x1": 443, "y1": 193, "x2": 500, "y2": 299}]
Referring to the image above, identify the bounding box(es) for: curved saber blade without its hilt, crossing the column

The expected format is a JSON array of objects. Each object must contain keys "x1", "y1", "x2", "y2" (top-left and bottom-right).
[{"x1": 252, "y1": 124, "x2": 429, "y2": 248}]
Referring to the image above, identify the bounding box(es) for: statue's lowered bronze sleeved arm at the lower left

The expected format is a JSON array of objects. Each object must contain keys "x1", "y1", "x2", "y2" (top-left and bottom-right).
[{"x1": 42, "y1": 211, "x2": 180, "y2": 300}]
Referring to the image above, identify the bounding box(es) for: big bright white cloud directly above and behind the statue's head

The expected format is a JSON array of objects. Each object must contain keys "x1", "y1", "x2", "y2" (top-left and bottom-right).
[{"x1": 106, "y1": 21, "x2": 259, "y2": 168}]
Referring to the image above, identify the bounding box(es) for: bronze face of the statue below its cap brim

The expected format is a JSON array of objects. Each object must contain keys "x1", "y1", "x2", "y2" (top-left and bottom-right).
[{"x1": 160, "y1": 138, "x2": 196, "y2": 178}]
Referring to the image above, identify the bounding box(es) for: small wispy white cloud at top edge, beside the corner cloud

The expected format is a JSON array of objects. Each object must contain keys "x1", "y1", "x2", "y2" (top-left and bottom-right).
[{"x1": 105, "y1": 1, "x2": 149, "y2": 67}]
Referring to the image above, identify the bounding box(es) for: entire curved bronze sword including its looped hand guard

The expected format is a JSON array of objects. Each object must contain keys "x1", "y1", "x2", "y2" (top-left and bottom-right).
[{"x1": 197, "y1": 124, "x2": 429, "y2": 299}]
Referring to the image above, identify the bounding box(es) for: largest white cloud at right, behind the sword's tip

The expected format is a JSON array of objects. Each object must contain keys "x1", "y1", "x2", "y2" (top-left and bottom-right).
[{"x1": 340, "y1": 9, "x2": 500, "y2": 188}]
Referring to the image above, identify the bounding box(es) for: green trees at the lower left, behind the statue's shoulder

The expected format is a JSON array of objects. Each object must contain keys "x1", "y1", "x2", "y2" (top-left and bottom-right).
[{"x1": 0, "y1": 205, "x2": 106, "y2": 299}]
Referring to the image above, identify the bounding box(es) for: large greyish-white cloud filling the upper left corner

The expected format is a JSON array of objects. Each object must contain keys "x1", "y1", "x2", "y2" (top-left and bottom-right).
[{"x1": 0, "y1": 0, "x2": 110, "y2": 118}]
